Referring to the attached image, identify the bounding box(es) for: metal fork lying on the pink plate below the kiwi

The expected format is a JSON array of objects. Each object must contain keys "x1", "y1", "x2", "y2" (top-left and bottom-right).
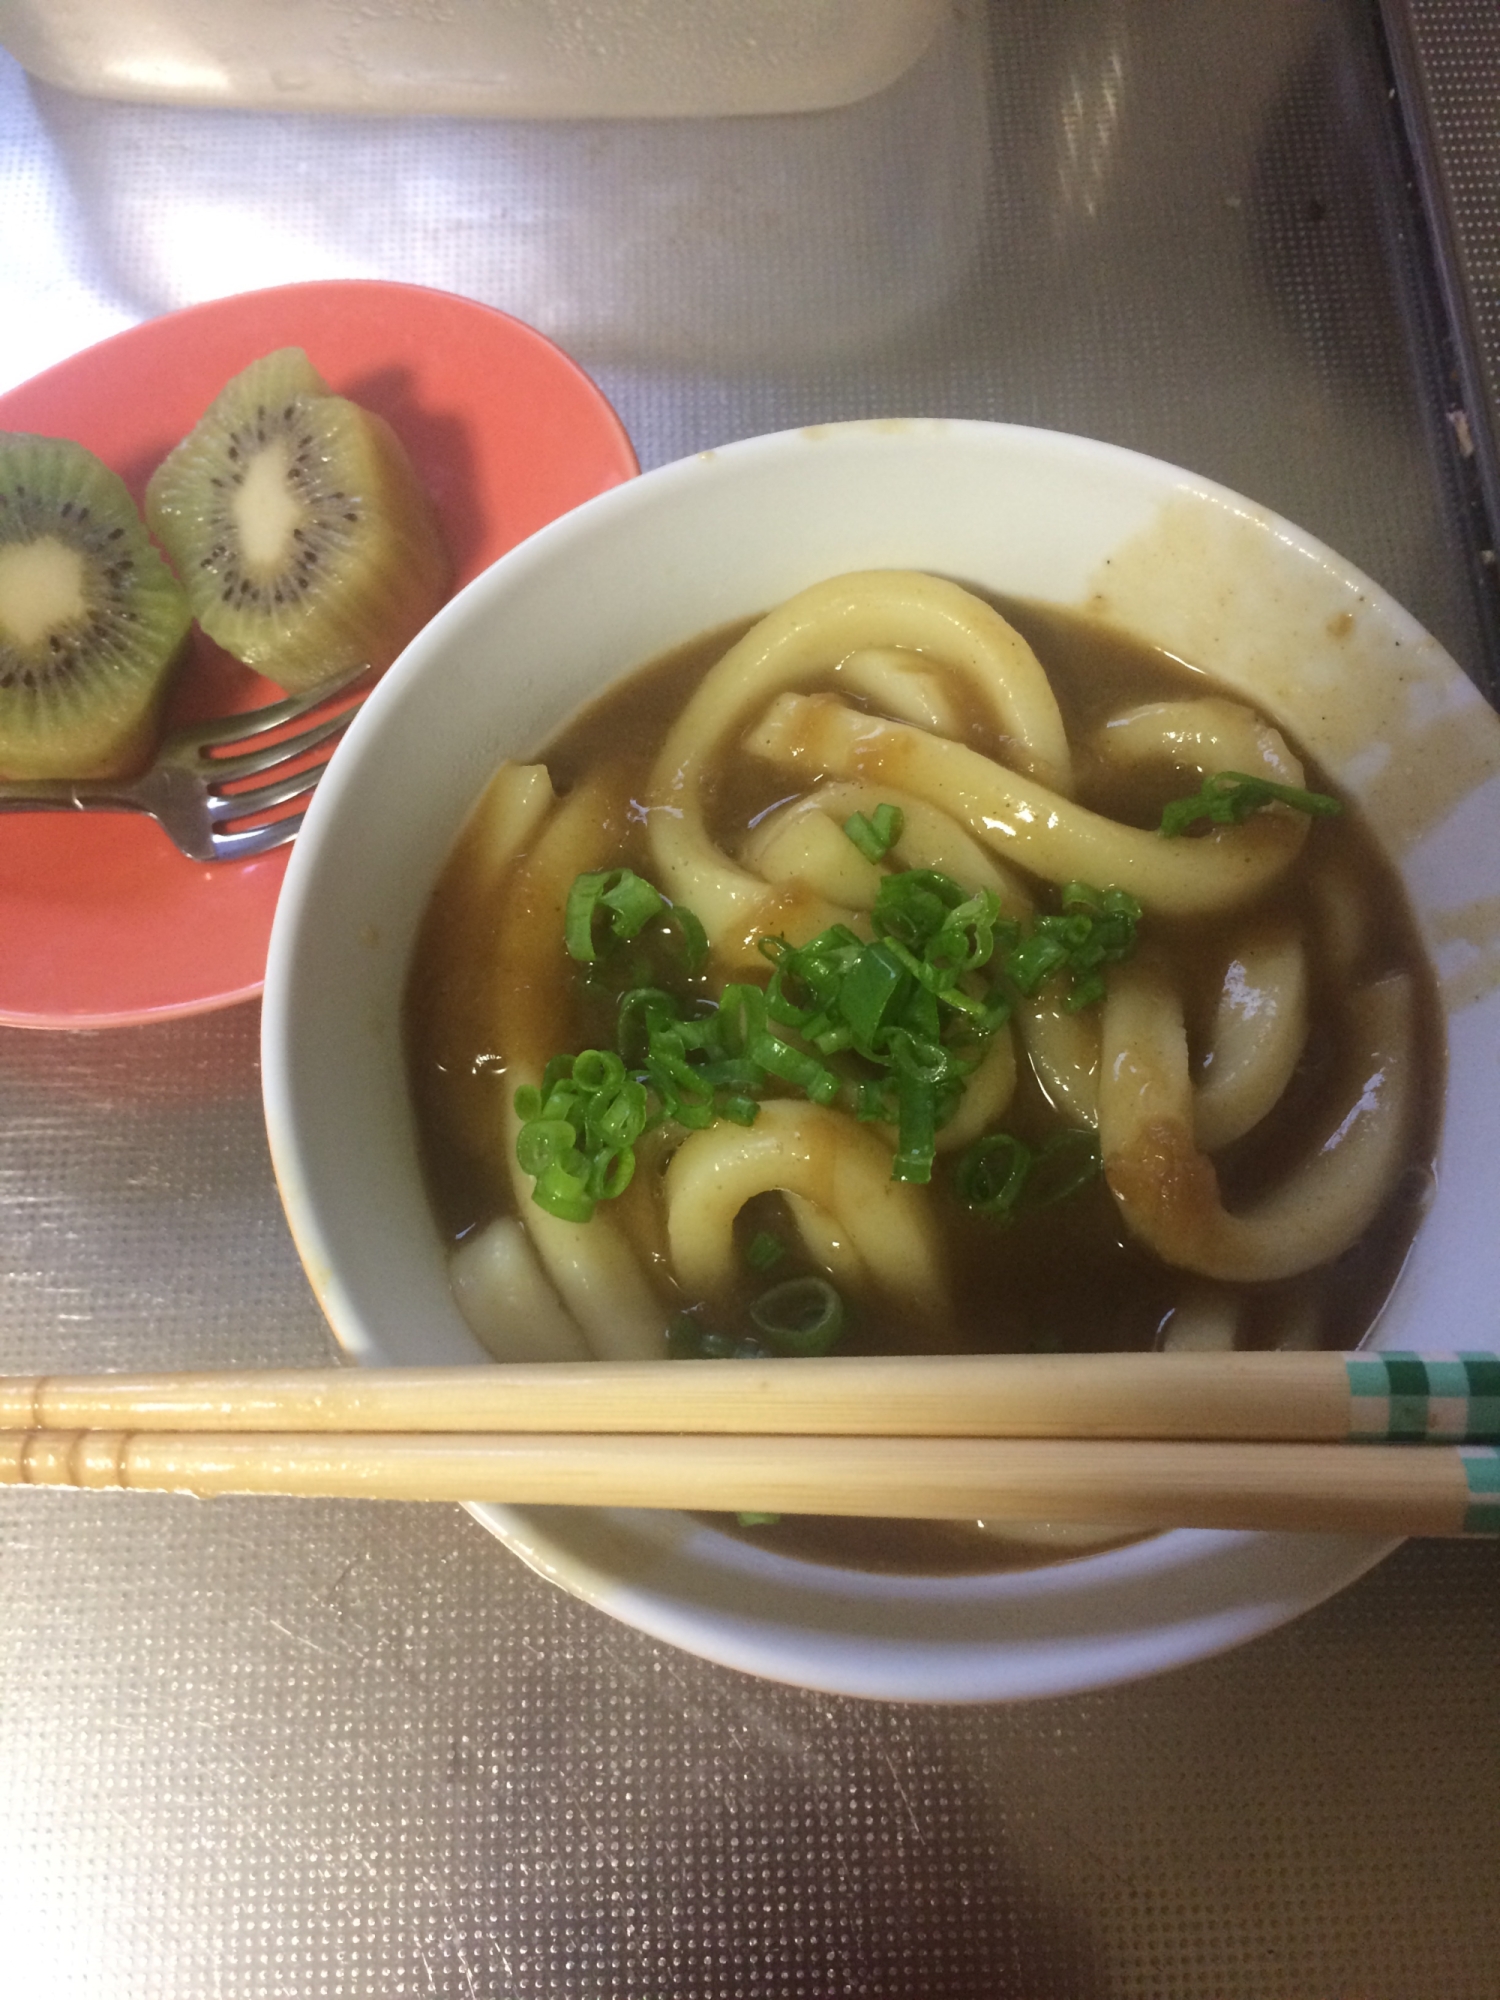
[{"x1": 0, "y1": 666, "x2": 370, "y2": 862}]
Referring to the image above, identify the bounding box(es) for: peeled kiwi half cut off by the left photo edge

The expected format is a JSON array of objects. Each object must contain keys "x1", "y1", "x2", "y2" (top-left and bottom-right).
[{"x1": 0, "y1": 432, "x2": 192, "y2": 778}]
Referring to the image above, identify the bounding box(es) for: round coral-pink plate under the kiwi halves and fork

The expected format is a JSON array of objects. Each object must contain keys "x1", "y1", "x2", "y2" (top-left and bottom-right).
[{"x1": 0, "y1": 278, "x2": 636, "y2": 1028}]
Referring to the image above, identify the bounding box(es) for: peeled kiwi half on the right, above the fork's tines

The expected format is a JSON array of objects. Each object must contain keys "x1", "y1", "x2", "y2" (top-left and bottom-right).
[{"x1": 146, "y1": 348, "x2": 452, "y2": 692}]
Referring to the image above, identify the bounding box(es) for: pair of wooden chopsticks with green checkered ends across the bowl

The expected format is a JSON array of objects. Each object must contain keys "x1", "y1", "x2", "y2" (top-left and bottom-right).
[{"x1": 0, "y1": 1352, "x2": 1500, "y2": 1536}]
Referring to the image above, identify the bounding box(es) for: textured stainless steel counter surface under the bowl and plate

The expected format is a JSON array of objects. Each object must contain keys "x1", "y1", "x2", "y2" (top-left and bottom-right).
[{"x1": 0, "y1": 0, "x2": 1500, "y2": 2000}]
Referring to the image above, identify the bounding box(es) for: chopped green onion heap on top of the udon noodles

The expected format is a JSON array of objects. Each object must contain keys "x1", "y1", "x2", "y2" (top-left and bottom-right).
[{"x1": 516, "y1": 864, "x2": 1140, "y2": 1222}]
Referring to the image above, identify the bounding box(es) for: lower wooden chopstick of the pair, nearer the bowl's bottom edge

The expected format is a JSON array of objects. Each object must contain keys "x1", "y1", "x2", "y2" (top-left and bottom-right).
[{"x1": 0, "y1": 1430, "x2": 1500, "y2": 1536}]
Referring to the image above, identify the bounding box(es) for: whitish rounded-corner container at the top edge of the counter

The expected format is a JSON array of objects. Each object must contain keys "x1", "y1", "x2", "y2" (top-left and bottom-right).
[{"x1": 4, "y1": 0, "x2": 946, "y2": 118}]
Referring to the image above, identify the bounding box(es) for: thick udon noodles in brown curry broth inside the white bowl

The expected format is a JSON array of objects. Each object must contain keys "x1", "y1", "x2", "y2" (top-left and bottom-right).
[{"x1": 408, "y1": 572, "x2": 1440, "y2": 1564}]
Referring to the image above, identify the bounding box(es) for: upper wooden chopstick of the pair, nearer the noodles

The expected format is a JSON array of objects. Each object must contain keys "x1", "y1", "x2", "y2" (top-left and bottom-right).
[{"x1": 0, "y1": 1352, "x2": 1500, "y2": 1444}]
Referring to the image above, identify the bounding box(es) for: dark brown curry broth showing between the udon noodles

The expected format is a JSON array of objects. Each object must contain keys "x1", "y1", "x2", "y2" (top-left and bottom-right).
[{"x1": 408, "y1": 600, "x2": 1442, "y2": 1570}]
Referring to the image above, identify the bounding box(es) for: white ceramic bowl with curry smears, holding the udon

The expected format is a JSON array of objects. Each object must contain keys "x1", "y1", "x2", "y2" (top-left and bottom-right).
[{"x1": 264, "y1": 422, "x2": 1500, "y2": 1700}]
